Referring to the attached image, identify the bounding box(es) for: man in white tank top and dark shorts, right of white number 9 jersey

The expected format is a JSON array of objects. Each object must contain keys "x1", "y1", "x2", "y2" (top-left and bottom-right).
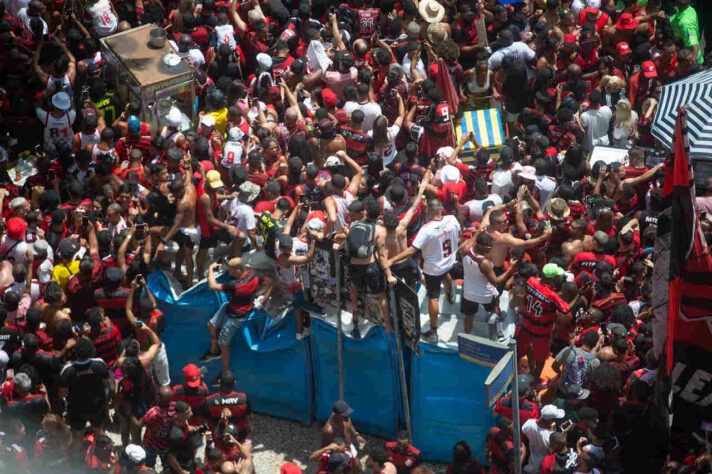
[{"x1": 460, "y1": 232, "x2": 517, "y2": 339}]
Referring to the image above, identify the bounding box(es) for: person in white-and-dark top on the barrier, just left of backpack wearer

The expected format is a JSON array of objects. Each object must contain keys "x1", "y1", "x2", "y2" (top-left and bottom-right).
[{"x1": 255, "y1": 228, "x2": 319, "y2": 341}]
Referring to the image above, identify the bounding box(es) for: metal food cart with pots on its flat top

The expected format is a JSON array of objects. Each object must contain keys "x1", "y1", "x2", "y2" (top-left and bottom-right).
[{"x1": 101, "y1": 25, "x2": 196, "y2": 131}]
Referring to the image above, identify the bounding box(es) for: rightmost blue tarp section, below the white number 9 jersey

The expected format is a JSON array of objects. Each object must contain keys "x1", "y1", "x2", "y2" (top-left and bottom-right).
[{"x1": 410, "y1": 342, "x2": 494, "y2": 462}]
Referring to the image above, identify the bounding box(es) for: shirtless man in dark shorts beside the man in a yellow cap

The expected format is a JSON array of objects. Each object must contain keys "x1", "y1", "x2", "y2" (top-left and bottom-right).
[{"x1": 161, "y1": 156, "x2": 200, "y2": 286}]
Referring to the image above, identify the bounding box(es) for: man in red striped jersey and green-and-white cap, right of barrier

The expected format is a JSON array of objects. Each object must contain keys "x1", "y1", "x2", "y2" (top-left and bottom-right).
[{"x1": 516, "y1": 263, "x2": 571, "y2": 378}]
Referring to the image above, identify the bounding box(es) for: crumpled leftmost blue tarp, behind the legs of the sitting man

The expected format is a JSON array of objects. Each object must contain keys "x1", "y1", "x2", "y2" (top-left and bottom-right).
[{"x1": 147, "y1": 272, "x2": 313, "y2": 423}]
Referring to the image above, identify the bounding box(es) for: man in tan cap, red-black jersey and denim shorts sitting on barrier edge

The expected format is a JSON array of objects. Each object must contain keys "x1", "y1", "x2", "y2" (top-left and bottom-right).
[{"x1": 199, "y1": 257, "x2": 266, "y2": 370}]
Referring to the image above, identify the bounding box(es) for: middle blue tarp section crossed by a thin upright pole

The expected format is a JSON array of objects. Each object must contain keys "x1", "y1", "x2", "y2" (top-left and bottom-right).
[{"x1": 311, "y1": 319, "x2": 402, "y2": 438}]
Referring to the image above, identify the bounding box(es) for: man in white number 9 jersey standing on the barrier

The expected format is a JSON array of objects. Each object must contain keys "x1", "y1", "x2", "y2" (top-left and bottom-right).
[{"x1": 393, "y1": 199, "x2": 461, "y2": 344}]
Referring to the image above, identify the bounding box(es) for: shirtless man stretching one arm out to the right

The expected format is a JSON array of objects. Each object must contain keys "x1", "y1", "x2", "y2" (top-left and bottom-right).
[{"x1": 480, "y1": 204, "x2": 551, "y2": 276}]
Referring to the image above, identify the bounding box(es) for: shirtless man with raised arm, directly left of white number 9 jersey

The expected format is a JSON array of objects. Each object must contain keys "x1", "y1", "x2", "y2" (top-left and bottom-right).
[{"x1": 383, "y1": 169, "x2": 433, "y2": 290}]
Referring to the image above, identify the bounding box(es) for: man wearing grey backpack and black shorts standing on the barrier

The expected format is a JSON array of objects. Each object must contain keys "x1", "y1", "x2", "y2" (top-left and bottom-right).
[{"x1": 346, "y1": 199, "x2": 396, "y2": 339}]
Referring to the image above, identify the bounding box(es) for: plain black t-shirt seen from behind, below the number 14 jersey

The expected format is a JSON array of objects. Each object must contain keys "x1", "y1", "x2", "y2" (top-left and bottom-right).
[{"x1": 59, "y1": 359, "x2": 109, "y2": 411}]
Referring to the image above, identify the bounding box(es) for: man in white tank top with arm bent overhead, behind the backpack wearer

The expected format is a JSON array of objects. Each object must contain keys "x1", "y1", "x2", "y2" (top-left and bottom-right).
[{"x1": 324, "y1": 151, "x2": 361, "y2": 241}]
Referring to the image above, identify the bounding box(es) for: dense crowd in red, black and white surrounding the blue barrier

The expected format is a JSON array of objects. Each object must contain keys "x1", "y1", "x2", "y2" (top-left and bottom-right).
[{"x1": 0, "y1": 0, "x2": 712, "y2": 474}]
